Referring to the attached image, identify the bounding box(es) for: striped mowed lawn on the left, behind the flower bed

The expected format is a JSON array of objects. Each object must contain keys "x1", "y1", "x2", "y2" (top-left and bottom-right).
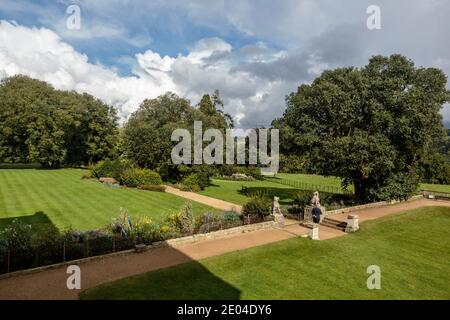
[{"x1": 0, "y1": 169, "x2": 216, "y2": 230}]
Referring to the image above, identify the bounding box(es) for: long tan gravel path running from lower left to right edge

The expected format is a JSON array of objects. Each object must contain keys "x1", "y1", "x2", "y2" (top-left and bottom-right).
[{"x1": 0, "y1": 199, "x2": 450, "y2": 299}]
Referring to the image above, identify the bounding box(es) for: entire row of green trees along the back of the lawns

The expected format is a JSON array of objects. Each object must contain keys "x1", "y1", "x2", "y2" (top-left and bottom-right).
[{"x1": 0, "y1": 55, "x2": 450, "y2": 201}]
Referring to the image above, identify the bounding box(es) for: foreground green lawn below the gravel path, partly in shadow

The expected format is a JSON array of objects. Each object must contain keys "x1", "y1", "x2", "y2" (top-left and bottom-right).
[{"x1": 80, "y1": 207, "x2": 450, "y2": 299}]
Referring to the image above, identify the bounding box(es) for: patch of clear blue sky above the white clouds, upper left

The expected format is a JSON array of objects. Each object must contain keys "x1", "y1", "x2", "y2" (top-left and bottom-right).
[{"x1": 0, "y1": 0, "x2": 266, "y2": 75}]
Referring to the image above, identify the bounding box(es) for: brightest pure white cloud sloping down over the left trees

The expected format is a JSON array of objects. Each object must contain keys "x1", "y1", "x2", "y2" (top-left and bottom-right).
[{"x1": 0, "y1": 21, "x2": 168, "y2": 120}]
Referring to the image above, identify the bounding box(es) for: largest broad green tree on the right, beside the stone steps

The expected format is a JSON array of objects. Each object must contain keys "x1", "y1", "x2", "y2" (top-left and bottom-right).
[{"x1": 273, "y1": 55, "x2": 450, "y2": 201}]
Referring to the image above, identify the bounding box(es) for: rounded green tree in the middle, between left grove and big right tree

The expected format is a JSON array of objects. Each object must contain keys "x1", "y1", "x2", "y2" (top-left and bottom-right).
[{"x1": 122, "y1": 92, "x2": 230, "y2": 169}]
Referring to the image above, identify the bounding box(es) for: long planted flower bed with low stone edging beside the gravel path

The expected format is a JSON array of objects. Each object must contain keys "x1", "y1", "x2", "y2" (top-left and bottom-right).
[{"x1": 0, "y1": 203, "x2": 271, "y2": 274}]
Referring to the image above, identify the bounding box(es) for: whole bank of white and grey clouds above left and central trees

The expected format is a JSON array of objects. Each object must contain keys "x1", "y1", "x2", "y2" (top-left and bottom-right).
[{"x1": 0, "y1": 21, "x2": 320, "y2": 126}]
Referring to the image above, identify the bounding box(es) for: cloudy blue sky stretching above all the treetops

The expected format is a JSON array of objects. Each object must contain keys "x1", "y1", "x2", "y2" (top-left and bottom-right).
[{"x1": 0, "y1": 0, "x2": 450, "y2": 128}]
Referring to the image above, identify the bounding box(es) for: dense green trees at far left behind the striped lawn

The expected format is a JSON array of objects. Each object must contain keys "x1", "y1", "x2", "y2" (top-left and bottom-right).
[{"x1": 0, "y1": 76, "x2": 117, "y2": 167}]
